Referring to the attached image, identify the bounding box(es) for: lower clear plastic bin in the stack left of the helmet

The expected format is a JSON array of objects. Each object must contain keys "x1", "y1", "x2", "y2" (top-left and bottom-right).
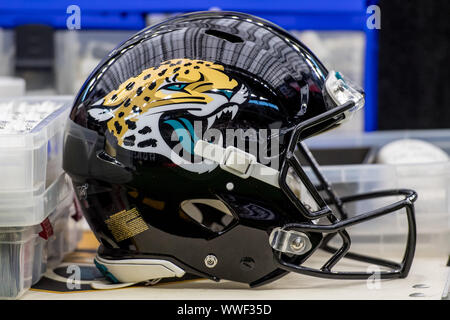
[{"x1": 0, "y1": 193, "x2": 83, "y2": 299}]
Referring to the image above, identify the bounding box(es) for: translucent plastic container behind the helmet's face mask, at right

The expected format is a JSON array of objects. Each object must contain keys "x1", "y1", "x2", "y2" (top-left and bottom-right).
[{"x1": 306, "y1": 130, "x2": 450, "y2": 254}]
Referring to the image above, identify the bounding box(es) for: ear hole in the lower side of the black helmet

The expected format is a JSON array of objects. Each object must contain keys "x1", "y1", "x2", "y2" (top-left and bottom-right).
[{"x1": 180, "y1": 199, "x2": 236, "y2": 232}]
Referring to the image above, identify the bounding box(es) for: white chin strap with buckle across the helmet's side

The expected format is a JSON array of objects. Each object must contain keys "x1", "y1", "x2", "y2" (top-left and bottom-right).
[{"x1": 194, "y1": 140, "x2": 280, "y2": 188}]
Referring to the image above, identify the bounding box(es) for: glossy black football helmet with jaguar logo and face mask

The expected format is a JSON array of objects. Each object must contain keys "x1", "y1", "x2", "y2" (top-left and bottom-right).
[{"x1": 63, "y1": 12, "x2": 417, "y2": 286}]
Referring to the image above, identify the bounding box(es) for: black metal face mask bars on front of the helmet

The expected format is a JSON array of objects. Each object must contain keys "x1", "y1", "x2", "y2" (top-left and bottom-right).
[{"x1": 275, "y1": 100, "x2": 417, "y2": 279}]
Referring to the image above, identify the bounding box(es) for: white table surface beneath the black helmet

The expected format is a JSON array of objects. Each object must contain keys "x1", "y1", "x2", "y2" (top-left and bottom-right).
[{"x1": 21, "y1": 250, "x2": 450, "y2": 300}]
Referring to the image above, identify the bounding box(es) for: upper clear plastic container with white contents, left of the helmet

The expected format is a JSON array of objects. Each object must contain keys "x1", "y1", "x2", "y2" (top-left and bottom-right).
[{"x1": 0, "y1": 97, "x2": 72, "y2": 227}]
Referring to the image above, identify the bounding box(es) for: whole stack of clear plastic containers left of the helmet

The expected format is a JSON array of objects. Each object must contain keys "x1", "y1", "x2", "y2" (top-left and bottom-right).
[{"x1": 0, "y1": 97, "x2": 82, "y2": 299}]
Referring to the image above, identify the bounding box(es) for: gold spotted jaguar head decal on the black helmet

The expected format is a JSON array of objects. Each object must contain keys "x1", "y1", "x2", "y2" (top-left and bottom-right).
[{"x1": 88, "y1": 59, "x2": 249, "y2": 173}]
